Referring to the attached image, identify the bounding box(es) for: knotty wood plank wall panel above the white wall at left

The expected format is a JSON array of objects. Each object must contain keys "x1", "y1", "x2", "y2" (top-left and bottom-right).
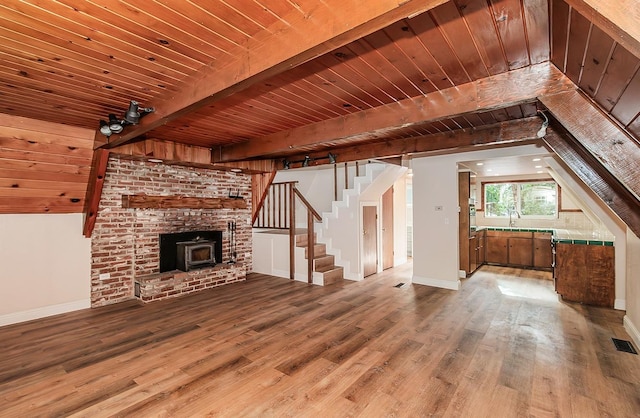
[{"x1": 0, "y1": 114, "x2": 95, "y2": 213}]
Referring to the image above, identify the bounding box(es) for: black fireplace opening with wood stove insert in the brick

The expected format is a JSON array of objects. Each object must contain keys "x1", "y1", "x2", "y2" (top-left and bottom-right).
[{"x1": 160, "y1": 231, "x2": 222, "y2": 273}]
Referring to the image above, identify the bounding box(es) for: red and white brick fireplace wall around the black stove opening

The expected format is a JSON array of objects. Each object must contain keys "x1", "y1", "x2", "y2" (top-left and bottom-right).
[{"x1": 91, "y1": 156, "x2": 252, "y2": 307}]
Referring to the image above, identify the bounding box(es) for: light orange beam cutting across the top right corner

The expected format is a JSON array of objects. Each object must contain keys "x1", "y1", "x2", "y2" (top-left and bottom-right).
[{"x1": 565, "y1": 0, "x2": 640, "y2": 58}]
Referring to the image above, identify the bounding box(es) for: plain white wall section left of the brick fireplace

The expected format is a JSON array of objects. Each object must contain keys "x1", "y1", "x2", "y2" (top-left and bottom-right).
[{"x1": 0, "y1": 214, "x2": 91, "y2": 325}]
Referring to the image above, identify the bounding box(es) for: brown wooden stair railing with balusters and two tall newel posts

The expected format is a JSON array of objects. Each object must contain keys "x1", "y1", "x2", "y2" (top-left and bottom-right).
[{"x1": 253, "y1": 181, "x2": 322, "y2": 283}]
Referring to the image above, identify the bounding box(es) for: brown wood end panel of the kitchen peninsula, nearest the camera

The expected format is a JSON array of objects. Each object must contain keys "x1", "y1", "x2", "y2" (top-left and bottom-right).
[{"x1": 553, "y1": 243, "x2": 615, "y2": 308}]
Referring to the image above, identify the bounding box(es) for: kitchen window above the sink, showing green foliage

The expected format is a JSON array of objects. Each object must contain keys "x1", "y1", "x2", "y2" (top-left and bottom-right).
[{"x1": 482, "y1": 181, "x2": 558, "y2": 218}]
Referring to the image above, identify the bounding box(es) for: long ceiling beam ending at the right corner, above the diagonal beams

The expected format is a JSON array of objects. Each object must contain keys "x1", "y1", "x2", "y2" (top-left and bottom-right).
[{"x1": 214, "y1": 63, "x2": 575, "y2": 161}]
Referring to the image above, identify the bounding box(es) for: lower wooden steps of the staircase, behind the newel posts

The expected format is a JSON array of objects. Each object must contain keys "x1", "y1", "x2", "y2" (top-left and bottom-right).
[{"x1": 295, "y1": 229, "x2": 344, "y2": 286}]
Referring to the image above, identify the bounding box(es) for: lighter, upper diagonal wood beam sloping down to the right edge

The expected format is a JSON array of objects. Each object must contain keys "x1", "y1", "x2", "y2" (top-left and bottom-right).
[{"x1": 540, "y1": 91, "x2": 640, "y2": 199}]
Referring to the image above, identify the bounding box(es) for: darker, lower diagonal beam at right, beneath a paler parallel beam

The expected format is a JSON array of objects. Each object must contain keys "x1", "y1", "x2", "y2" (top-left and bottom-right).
[{"x1": 545, "y1": 129, "x2": 640, "y2": 237}]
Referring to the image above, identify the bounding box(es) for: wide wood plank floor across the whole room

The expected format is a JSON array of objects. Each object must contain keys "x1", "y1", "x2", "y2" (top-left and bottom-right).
[{"x1": 0, "y1": 264, "x2": 640, "y2": 418}]
